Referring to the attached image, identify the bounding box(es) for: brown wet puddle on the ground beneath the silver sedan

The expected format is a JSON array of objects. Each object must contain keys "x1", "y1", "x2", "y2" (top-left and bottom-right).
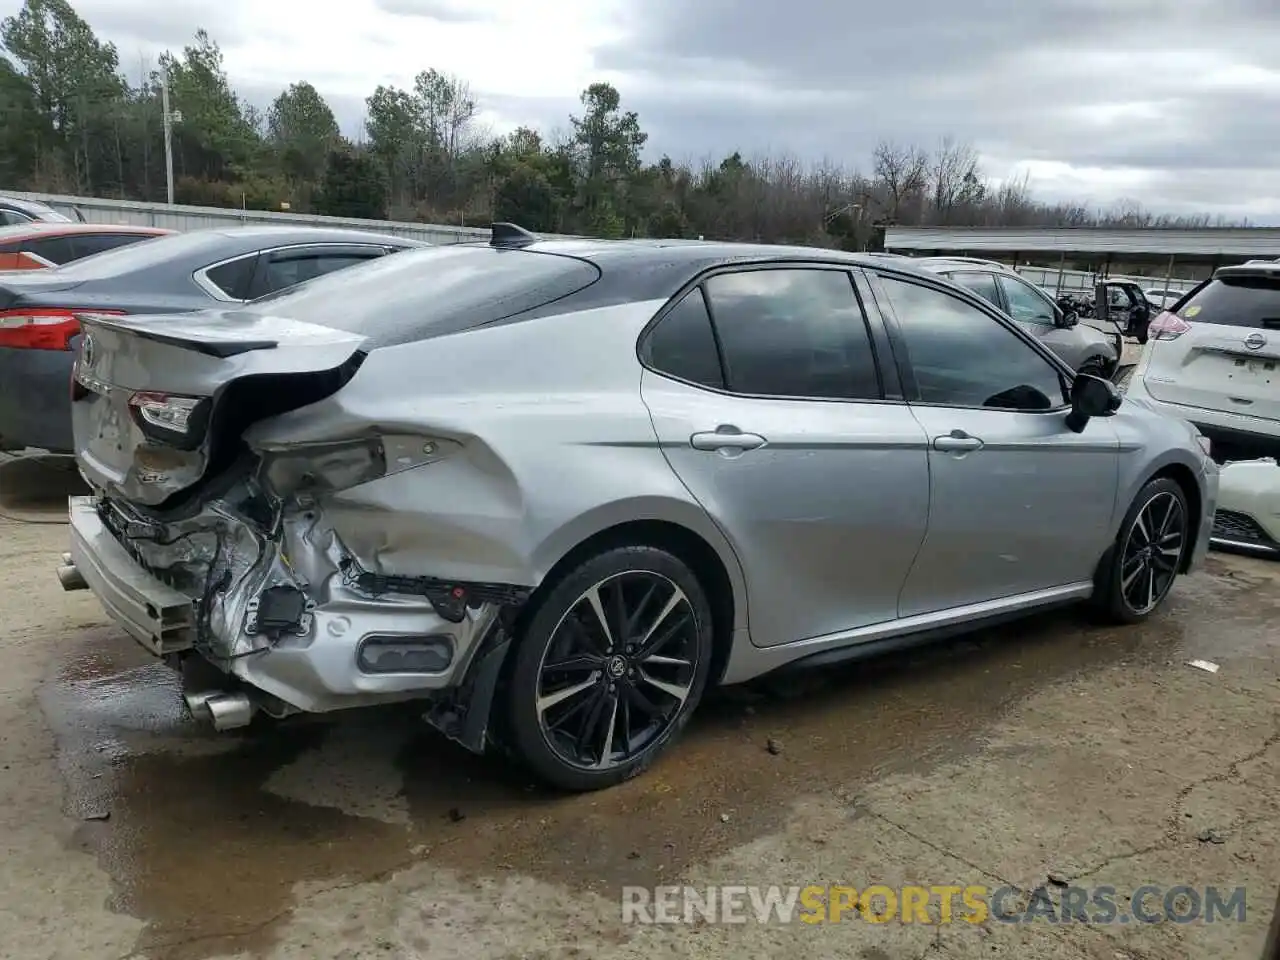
[{"x1": 41, "y1": 555, "x2": 1274, "y2": 960}]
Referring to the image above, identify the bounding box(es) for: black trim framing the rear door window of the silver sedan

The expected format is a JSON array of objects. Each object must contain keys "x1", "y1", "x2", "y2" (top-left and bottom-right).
[{"x1": 636, "y1": 260, "x2": 905, "y2": 403}]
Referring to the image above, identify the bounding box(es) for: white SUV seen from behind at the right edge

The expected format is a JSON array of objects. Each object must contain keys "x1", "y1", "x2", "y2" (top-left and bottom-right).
[{"x1": 1128, "y1": 261, "x2": 1280, "y2": 460}]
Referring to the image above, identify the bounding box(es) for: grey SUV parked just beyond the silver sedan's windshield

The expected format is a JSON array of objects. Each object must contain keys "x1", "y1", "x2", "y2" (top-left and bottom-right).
[{"x1": 911, "y1": 257, "x2": 1124, "y2": 378}]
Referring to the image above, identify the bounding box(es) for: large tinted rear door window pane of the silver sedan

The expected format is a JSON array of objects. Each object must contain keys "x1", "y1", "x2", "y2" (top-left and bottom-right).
[{"x1": 707, "y1": 270, "x2": 883, "y2": 399}]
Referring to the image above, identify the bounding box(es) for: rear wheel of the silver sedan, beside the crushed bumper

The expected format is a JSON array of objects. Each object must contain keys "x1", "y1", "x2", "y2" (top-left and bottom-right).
[{"x1": 506, "y1": 545, "x2": 713, "y2": 791}]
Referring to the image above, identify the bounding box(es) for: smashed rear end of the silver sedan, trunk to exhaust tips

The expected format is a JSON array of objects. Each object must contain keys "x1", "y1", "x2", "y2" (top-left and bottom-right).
[{"x1": 63, "y1": 310, "x2": 526, "y2": 749}]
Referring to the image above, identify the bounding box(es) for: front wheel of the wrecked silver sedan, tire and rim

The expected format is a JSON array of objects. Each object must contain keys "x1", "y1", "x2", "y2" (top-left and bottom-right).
[{"x1": 1094, "y1": 477, "x2": 1192, "y2": 623}]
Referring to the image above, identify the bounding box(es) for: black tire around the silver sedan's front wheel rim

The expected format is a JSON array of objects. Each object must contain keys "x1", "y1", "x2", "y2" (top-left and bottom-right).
[{"x1": 1093, "y1": 477, "x2": 1194, "y2": 623}]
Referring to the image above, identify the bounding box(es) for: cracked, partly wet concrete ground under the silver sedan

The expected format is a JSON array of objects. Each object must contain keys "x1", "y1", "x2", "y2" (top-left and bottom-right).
[{"x1": 0, "y1": 453, "x2": 1280, "y2": 960}]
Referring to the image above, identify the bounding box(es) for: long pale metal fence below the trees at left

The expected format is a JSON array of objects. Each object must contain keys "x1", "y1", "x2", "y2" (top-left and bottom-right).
[{"x1": 3, "y1": 191, "x2": 581, "y2": 243}]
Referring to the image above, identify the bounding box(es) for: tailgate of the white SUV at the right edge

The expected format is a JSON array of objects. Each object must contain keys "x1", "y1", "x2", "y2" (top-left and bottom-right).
[{"x1": 1144, "y1": 268, "x2": 1280, "y2": 420}]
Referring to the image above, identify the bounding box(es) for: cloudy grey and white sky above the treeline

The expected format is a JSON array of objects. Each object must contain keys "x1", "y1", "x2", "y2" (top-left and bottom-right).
[{"x1": 0, "y1": 0, "x2": 1280, "y2": 223}]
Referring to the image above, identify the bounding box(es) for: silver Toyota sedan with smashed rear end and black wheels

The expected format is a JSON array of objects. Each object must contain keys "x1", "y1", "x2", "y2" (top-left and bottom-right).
[{"x1": 59, "y1": 225, "x2": 1217, "y2": 790}]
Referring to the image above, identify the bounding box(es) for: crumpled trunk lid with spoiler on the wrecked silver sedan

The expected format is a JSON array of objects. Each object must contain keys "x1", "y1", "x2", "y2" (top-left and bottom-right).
[{"x1": 72, "y1": 310, "x2": 365, "y2": 507}]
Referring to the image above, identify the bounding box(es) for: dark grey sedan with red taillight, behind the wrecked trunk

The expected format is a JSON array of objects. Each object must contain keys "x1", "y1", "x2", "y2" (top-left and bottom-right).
[{"x1": 0, "y1": 227, "x2": 425, "y2": 452}]
